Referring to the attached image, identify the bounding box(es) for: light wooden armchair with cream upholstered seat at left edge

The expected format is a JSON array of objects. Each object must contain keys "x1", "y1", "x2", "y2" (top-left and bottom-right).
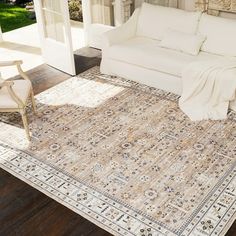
[{"x1": 0, "y1": 61, "x2": 36, "y2": 140}]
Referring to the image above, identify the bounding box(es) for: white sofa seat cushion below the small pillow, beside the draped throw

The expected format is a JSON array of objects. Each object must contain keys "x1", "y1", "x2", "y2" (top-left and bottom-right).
[{"x1": 108, "y1": 37, "x2": 219, "y2": 77}]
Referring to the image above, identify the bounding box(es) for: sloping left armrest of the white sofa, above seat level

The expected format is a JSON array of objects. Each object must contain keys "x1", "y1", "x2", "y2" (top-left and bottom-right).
[{"x1": 102, "y1": 9, "x2": 140, "y2": 50}]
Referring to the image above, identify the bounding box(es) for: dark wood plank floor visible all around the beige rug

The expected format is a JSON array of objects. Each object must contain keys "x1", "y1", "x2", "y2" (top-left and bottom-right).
[{"x1": 0, "y1": 48, "x2": 236, "y2": 236}]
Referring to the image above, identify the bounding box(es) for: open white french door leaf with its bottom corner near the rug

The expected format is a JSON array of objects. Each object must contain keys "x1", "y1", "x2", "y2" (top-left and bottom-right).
[{"x1": 34, "y1": 0, "x2": 75, "y2": 75}]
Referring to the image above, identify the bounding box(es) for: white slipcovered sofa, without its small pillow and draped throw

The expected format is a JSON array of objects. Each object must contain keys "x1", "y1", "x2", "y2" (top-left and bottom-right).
[{"x1": 101, "y1": 3, "x2": 236, "y2": 99}]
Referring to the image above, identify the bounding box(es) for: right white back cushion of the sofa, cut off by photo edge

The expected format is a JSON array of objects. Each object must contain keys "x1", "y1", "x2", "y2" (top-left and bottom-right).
[{"x1": 199, "y1": 14, "x2": 236, "y2": 56}]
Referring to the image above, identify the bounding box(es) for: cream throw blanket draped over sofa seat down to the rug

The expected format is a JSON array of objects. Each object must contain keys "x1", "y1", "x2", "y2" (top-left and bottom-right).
[{"x1": 179, "y1": 59, "x2": 236, "y2": 121}]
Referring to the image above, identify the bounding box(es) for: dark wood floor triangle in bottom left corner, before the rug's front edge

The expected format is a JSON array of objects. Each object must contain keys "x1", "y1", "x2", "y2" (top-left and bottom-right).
[{"x1": 0, "y1": 170, "x2": 110, "y2": 236}]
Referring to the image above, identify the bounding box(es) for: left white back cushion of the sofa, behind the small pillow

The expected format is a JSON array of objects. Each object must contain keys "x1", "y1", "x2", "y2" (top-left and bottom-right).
[{"x1": 136, "y1": 3, "x2": 201, "y2": 40}]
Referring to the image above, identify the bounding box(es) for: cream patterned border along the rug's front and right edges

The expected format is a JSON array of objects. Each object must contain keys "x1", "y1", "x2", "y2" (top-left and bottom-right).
[{"x1": 0, "y1": 143, "x2": 236, "y2": 236}]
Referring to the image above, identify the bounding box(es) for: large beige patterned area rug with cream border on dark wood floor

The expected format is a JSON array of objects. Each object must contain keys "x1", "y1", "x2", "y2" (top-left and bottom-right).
[{"x1": 0, "y1": 67, "x2": 236, "y2": 236}]
